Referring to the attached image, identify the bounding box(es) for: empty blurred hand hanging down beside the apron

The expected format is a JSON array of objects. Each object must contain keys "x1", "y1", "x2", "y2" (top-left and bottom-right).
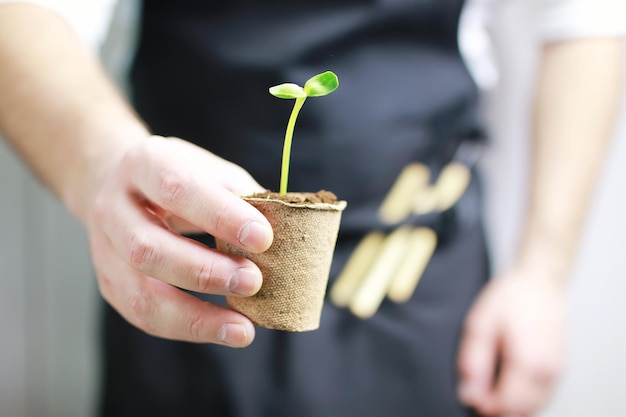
[{"x1": 459, "y1": 270, "x2": 565, "y2": 417}]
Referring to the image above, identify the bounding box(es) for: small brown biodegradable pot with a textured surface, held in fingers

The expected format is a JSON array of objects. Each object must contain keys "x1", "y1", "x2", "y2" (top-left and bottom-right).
[{"x1": 217, "y1": 193, "x2": 346, "y2": 332}]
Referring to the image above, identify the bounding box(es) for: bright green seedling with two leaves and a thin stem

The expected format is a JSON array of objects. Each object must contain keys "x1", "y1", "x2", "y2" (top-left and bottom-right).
[{"x1": 270, "y1": 71, "x2": 339, "y2": 194}]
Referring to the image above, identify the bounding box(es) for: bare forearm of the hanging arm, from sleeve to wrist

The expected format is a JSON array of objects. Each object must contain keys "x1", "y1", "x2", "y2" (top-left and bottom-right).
[{"x1": 518, "y1": 38, "x2": 623, "y2": 281}]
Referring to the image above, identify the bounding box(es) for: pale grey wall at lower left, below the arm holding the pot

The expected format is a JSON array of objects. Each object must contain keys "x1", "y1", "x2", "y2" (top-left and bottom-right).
[{"x1": 0, "y1": 142, "x2": 98, "y2": 417}]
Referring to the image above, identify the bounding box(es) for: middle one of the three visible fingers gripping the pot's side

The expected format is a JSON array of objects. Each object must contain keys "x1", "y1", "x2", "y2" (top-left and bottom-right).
[{"x1": 102, "y1": 192, "x2": 262, "y2": 296}]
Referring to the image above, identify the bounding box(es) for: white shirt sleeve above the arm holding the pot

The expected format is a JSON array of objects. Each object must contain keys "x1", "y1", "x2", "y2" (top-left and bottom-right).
[{"x1": 0, "y1": 0, "x2": 117, "y2": 51}]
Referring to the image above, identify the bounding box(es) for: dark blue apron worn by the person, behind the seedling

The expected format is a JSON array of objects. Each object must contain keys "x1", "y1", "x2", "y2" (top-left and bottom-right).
[{"x1": 101, "y1": 0, "x2": 488, "y2": 417}]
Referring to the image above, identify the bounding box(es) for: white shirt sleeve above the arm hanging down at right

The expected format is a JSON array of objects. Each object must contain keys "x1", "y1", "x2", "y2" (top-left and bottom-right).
[{"x1": 531, "y1": 0, "x2": 626, "y2": 41}]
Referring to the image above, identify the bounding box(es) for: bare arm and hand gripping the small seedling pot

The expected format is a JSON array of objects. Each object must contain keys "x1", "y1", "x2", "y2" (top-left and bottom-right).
[{"x1": 0, "y1": 4, "x2": 272, "y2": 347}]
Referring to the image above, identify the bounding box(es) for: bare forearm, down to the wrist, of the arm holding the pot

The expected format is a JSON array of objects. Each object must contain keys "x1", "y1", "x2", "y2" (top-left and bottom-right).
[{"x1": 0, "y1": 4, "x2": 148, "y2": 220}]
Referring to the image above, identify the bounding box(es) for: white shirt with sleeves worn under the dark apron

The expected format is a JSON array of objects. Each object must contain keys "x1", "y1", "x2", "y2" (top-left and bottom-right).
[{"x1": 0, "y1": 0, "x2": 626, "y2": 271}]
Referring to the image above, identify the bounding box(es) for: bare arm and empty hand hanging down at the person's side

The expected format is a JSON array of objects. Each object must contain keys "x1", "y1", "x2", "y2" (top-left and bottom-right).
[{"x1": 459, "y1": 38, "x2": 623, "y2": 416}]
